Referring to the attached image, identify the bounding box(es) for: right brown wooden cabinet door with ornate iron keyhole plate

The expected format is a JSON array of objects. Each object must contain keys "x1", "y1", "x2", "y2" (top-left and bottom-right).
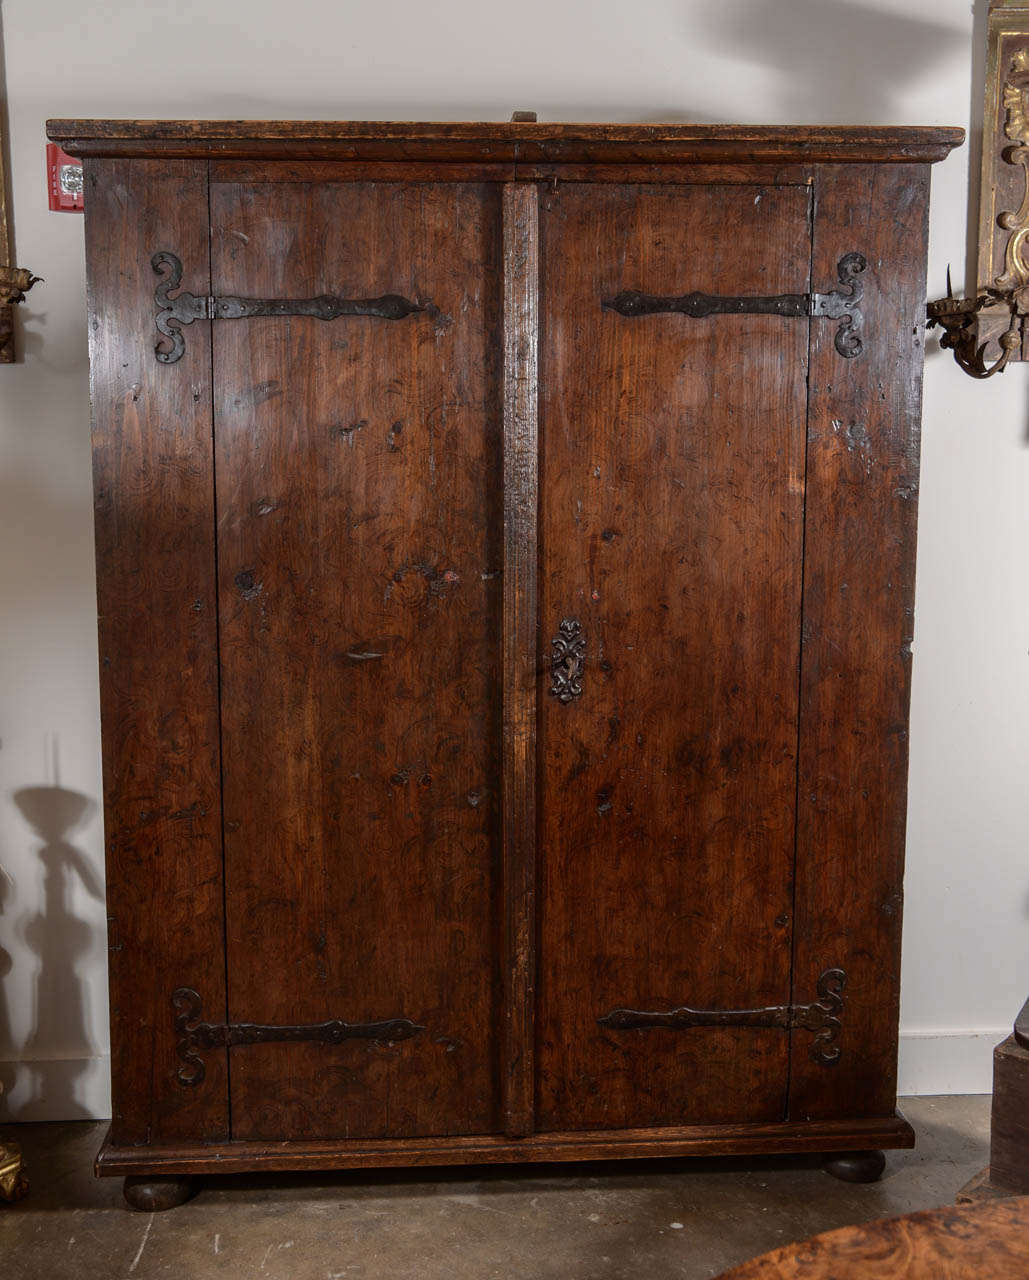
[{"x1": 536, "y1": 183, "x2": 813, "y2": 1130}]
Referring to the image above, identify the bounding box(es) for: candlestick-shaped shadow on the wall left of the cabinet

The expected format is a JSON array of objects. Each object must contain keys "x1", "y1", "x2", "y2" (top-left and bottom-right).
[{"x1": 0, "y1": 786, "x2": 104, "y2": 1120}]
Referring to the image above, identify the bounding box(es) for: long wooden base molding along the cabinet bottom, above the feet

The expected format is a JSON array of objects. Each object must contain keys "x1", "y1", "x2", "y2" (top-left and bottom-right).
[{"x1": 96, "y1": 1114, "x2": 915, "y2": 1178}]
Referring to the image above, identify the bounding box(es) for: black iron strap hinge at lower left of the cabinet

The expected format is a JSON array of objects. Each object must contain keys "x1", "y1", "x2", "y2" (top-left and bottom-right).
[{"x1": 172, "y1": 987, "x2": 425, "y2": 1085}]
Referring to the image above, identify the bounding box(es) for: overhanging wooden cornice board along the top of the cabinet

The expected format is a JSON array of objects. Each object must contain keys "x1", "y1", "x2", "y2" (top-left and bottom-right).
[{"x1": 46, "y1": 120, "x2": 965, "y2": 164}]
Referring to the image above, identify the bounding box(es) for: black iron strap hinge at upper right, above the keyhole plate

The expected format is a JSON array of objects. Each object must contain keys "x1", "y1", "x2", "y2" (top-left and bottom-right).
[{"x1": 602, "y1": 253, "x2": 868, "y2": 360}]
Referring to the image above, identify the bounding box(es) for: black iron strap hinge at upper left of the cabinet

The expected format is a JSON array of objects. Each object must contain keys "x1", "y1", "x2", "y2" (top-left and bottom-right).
[{"x1": 150, "y1": 252, "x2": 426, "y2": 365}]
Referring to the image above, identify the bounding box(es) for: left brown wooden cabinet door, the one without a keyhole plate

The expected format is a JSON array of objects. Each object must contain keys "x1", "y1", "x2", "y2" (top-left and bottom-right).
[{"x1": 211, "y1": 182, "x2": 503, "y2": 1140}]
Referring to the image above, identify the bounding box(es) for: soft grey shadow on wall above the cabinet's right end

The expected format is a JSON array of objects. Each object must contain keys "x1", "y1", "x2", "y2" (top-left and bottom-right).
[{"x1": 683, "y1": 0, "x2": 969, "y2": 124}]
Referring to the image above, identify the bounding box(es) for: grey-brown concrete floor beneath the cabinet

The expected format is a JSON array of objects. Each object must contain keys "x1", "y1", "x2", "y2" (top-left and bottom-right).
[{"x1": 0, "y1": 1097, "x2": 989, "y2": 1280}]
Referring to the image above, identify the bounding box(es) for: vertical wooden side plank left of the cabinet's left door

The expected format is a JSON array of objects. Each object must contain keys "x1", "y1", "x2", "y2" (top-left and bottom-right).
[{"x1": 86, "y1": 160, "x2": 228, "y2": 1146}]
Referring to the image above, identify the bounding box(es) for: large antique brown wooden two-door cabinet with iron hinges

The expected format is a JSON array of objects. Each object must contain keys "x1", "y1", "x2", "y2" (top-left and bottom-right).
[{"x1": 50, "y1": 122, "x2": 961, "y2": 1204}]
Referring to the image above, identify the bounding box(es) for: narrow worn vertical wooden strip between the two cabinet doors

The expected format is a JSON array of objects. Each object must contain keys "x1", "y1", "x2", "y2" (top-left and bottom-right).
[{"x1": 503, "y1": 183, "x2": 539, "y2": 1137}]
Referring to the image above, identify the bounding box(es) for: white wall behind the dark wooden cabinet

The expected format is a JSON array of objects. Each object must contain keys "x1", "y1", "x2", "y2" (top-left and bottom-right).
[{"x1": 0, "y1": 0, "x2": 1029, "y2": 1119}]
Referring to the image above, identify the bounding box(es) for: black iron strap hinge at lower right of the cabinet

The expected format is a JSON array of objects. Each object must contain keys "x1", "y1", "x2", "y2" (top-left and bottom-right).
[{"x1": 596, "y1": 969, "x2": 847, "y2": 1066}]
